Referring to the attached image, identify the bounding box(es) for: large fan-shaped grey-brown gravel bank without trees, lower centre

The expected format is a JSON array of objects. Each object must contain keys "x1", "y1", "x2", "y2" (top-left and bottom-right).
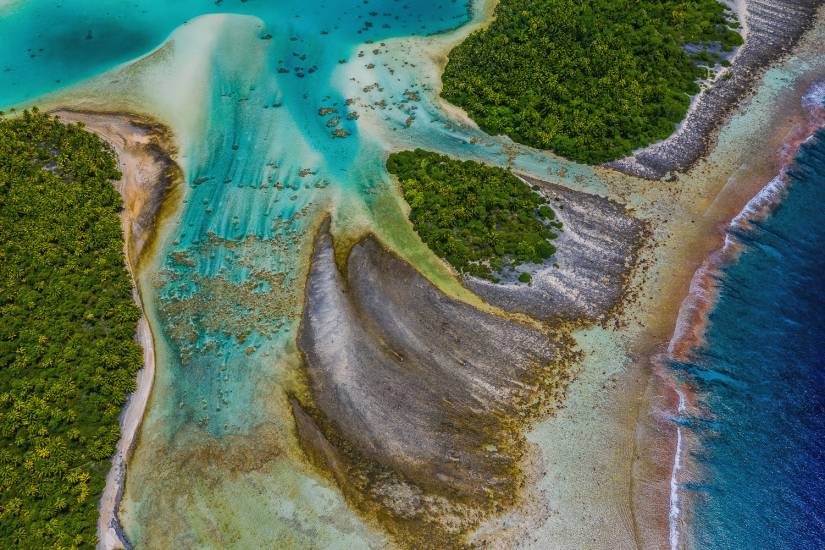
[{"x1": 293, "y1": 222, "x2": 572, "y2": 548}]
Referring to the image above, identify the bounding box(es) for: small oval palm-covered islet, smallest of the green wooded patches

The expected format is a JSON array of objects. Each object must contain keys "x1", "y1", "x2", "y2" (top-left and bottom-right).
[{"x1": 387, "y1": 149, "x2": 562, "y2": 282}]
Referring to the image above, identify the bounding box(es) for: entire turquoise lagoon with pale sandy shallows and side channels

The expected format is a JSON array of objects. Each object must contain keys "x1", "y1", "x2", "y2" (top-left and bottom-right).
[{"x1": 0, "y1": 0, "x2": 602, "y2": 548}]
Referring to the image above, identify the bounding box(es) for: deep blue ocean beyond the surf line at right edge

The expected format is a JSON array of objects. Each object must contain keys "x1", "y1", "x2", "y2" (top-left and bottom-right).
[{"x1": 677, "y1": 131, "x2": 825, "y2": 549}]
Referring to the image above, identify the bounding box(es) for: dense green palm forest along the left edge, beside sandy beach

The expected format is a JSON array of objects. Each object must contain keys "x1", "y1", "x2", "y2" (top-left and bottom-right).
[{"x1": 0, "y1": 111, "x2": 142, "y2": 548}]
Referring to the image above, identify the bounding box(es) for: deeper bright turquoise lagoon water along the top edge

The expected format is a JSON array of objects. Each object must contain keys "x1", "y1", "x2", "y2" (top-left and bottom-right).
[{"x1": 0, "y1": 0, "x2": 467, "y2": 106}]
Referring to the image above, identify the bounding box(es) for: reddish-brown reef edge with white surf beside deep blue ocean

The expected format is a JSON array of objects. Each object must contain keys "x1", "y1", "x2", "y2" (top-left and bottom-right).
[{"x1": 633, "y1": 35, "x2": 825, "y2": 549}]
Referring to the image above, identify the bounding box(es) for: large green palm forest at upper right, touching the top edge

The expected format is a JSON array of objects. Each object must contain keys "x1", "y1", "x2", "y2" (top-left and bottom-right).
[{"x1": 442, "y1": 0, "x2": 742, "y2": 163}]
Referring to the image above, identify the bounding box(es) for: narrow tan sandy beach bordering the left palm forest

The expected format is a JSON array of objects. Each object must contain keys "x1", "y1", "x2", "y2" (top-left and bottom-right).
[{"x1": 52, "y1": 110, "x2": 180, "y2": 550}]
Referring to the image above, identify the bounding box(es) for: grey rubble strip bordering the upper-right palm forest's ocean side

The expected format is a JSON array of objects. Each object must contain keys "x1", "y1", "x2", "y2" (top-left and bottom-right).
[{"x1": 606, "y1": 0, "x2": 825, "y2": 179}]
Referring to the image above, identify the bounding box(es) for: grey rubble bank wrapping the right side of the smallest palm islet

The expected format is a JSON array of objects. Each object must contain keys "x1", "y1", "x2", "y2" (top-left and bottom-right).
[{"x1": 465, "y1": 175, "x2": 646, "y2": 321}]
